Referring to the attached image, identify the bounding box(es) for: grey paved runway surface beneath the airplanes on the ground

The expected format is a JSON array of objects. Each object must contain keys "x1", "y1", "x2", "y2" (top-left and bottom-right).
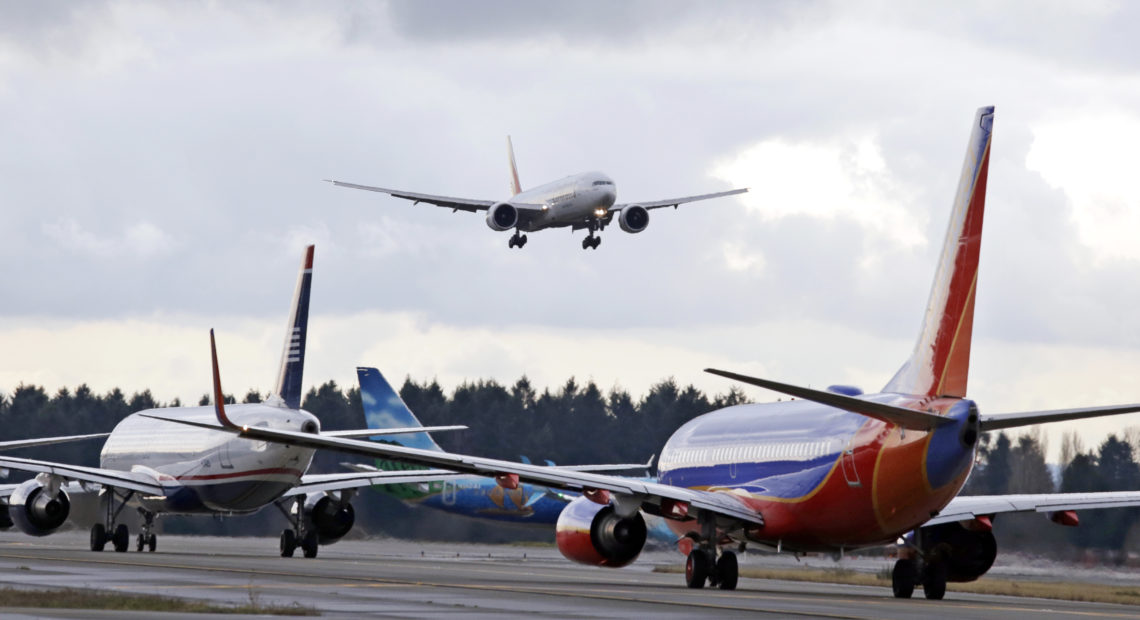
[{"x1": 0, "y1": 532, "x2": 1138, "y2": 620}]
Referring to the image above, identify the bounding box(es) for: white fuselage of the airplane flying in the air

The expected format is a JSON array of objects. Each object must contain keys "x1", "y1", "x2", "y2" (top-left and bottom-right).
[{"x1": 507, "y1": 172, "x2": 618, "y2": 231}]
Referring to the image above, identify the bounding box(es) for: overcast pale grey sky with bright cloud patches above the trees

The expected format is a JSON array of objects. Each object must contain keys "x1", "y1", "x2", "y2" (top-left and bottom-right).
[{"x1": 0, "y1": 1, "x2": 1140, "y2": 460}]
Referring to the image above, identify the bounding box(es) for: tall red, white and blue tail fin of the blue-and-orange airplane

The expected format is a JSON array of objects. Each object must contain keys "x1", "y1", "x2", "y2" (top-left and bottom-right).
[{"x1": 884, "y1": 106, "x2": 994, "y2": 398}]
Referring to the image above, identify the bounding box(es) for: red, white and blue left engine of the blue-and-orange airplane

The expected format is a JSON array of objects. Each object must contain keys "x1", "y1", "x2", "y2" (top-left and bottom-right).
[{"x1": 554, "y1": 497, "x2": 648, "y2": 569}]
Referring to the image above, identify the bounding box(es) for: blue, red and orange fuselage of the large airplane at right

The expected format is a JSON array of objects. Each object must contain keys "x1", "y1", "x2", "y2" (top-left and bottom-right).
[{"x1": 659, "y1": 394, "x2": 977, "y2": 550}]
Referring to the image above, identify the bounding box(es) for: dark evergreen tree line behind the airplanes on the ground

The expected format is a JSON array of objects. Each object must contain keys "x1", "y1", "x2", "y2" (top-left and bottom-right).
[{"x1": 0, "y1": 377, "x2": 1140, "y2": 562}]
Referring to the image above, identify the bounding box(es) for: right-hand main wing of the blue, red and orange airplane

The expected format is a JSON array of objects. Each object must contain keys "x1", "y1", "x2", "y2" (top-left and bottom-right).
[{"x1": 923, "y1": 491, "x2": 1140, "y2": 525}]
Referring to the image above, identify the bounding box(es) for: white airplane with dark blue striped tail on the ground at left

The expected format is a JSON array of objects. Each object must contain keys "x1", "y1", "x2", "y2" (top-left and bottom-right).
[{"x1": 0, "y1": 245, "x2": 464, "y2": 557}]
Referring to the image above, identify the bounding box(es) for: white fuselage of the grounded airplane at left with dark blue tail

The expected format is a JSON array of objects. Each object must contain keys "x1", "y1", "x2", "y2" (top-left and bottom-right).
[{"x1": 99, "y1": 405, "x2": 319, "y2": 513}]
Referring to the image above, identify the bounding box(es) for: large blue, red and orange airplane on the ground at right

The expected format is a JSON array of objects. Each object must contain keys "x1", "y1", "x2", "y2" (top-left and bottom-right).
[{"x1": 165, "y1": 107, "x2": 1140, "y2": 599}]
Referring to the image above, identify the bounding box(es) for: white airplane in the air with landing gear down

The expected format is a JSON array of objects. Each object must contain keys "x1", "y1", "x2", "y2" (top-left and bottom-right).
[{"x1": 325, "y1": 136, "x2": 748, "y2": 250}]
